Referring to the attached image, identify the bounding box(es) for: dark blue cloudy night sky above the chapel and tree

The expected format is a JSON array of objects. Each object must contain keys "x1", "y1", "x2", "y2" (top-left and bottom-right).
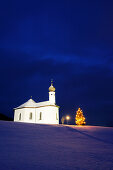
[{"x1": 0, "y1": 0, "x2": 113, "y2": 126}]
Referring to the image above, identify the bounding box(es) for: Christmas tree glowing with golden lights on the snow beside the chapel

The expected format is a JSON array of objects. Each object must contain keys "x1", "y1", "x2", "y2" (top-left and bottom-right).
[{"x1": 75, "y1": 108, "x2": 86, "y2": 125}]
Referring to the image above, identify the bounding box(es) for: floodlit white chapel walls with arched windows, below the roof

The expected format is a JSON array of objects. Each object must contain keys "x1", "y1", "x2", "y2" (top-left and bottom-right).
[{"x1": 14, "y1": 106, "x2": 59, "y2": 124}]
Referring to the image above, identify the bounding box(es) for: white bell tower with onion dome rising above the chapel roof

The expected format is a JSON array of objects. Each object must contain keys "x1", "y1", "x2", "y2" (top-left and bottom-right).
[{"x1": 49, "y1": 81, "x2": 55, "y2": 104}]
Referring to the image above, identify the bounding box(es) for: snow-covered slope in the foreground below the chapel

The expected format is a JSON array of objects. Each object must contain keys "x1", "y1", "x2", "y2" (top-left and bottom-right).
[{"x1": 0, "y1": 121, "x2": 113, "y2": 170}]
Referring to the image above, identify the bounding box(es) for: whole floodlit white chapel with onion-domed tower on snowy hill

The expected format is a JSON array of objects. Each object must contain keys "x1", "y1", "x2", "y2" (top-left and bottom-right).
[{"x1": 14, "y1": 82, "x2": 59, "y2": 124}]
